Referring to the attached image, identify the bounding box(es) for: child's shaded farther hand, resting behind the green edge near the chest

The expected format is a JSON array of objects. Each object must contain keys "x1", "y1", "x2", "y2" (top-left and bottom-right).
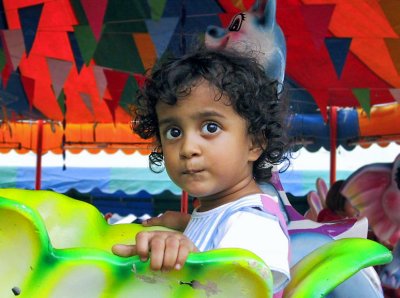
[{"x1": 142, "y1": 211, "x2": 190, "y2": 232}]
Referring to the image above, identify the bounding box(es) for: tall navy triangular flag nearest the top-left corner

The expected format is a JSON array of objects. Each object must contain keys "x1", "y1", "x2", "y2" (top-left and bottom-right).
[{"x1": 18, "y1": 3, "x2": 43, "y2": 55}]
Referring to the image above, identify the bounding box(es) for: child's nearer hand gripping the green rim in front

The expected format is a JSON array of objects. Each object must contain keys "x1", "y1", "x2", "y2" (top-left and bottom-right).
[{"x1": 112, "y1": 231, "x2": 198, "y2": 271}]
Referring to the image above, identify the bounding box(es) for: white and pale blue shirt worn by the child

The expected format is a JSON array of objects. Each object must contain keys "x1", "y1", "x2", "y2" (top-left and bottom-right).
[{"x1": 184, "y1": 194, "x2": 290, "y2": 293}]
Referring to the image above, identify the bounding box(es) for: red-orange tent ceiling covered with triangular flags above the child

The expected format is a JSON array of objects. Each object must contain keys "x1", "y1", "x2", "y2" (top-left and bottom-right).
[{"x1": 0, "y1": 0, "x2": 400, "y2": 123}]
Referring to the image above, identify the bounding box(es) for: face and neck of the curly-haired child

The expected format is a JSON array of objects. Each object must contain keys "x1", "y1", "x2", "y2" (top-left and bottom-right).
[{"x1": 156, "y1": 81, "x2": 261, "y2": 210}]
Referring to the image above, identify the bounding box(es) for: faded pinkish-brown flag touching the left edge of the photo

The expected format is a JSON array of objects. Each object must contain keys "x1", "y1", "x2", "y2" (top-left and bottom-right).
[{"x1": 1, "y1": 30, "x2": 25, "y2": 70}]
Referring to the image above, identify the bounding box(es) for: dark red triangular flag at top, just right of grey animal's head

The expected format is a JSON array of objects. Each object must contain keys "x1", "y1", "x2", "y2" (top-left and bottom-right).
[{"x1": 301, "y1": 4, "x2": 335, "y2": 49}]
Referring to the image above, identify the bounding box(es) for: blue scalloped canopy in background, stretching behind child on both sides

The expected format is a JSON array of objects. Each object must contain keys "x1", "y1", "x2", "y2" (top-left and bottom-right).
[{"x1": 0, "y1": 167, "x2": 351, "y2": 198}]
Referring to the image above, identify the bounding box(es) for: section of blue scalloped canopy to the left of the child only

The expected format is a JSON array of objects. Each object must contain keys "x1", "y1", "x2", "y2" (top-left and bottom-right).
[{"x1": 0, "y1": 167, "x2": 182, "y2": 197}]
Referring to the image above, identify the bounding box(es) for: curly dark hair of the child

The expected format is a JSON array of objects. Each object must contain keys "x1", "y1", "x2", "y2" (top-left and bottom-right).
[{"x1": 132, "y1": 48, "x2": 289, "y2": 182}]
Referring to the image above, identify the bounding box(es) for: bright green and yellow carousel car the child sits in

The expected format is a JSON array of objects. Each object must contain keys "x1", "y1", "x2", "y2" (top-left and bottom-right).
[{"x1": 0, "y1": 189, "x2": 392, "y2": 298}]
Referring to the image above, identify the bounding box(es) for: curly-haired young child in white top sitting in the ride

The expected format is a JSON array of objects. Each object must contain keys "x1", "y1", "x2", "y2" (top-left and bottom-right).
[{"x1": 113, "y1": 49, "x2": 289, "y2": 292}]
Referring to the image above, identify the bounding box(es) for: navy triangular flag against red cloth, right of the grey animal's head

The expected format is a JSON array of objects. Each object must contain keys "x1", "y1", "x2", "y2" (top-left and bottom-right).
[{"x1": 325, "y1": 37, "x2": 352, "y2": 78}]
